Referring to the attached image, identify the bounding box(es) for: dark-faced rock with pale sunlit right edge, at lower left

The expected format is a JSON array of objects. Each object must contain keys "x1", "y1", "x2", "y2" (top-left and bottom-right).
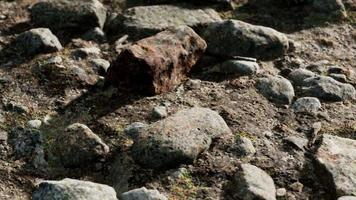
[{"x1": 53, "y1": 123, "x2": 109, "y2": 167}]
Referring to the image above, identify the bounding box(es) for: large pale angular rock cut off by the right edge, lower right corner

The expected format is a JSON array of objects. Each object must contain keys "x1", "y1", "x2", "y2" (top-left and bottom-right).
[{"x1": 315, "y1": 134, "x2": 356, "y2": 197}]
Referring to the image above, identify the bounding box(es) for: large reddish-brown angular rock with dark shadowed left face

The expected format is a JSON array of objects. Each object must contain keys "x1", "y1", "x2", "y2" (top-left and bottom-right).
[{"x1": 107, "y1": 26, "x2": 206, "y2": 95}]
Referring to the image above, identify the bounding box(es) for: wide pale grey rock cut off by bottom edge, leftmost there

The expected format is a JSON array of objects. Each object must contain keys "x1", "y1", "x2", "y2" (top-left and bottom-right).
[{"x1": 32, "y1": 178, "x2": 117, "y2": 200}]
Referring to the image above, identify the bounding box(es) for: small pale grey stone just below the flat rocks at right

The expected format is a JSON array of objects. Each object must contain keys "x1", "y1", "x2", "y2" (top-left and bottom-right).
[{"x1": 293, "y1": 97, "x2": 321, "y2": 114}]
